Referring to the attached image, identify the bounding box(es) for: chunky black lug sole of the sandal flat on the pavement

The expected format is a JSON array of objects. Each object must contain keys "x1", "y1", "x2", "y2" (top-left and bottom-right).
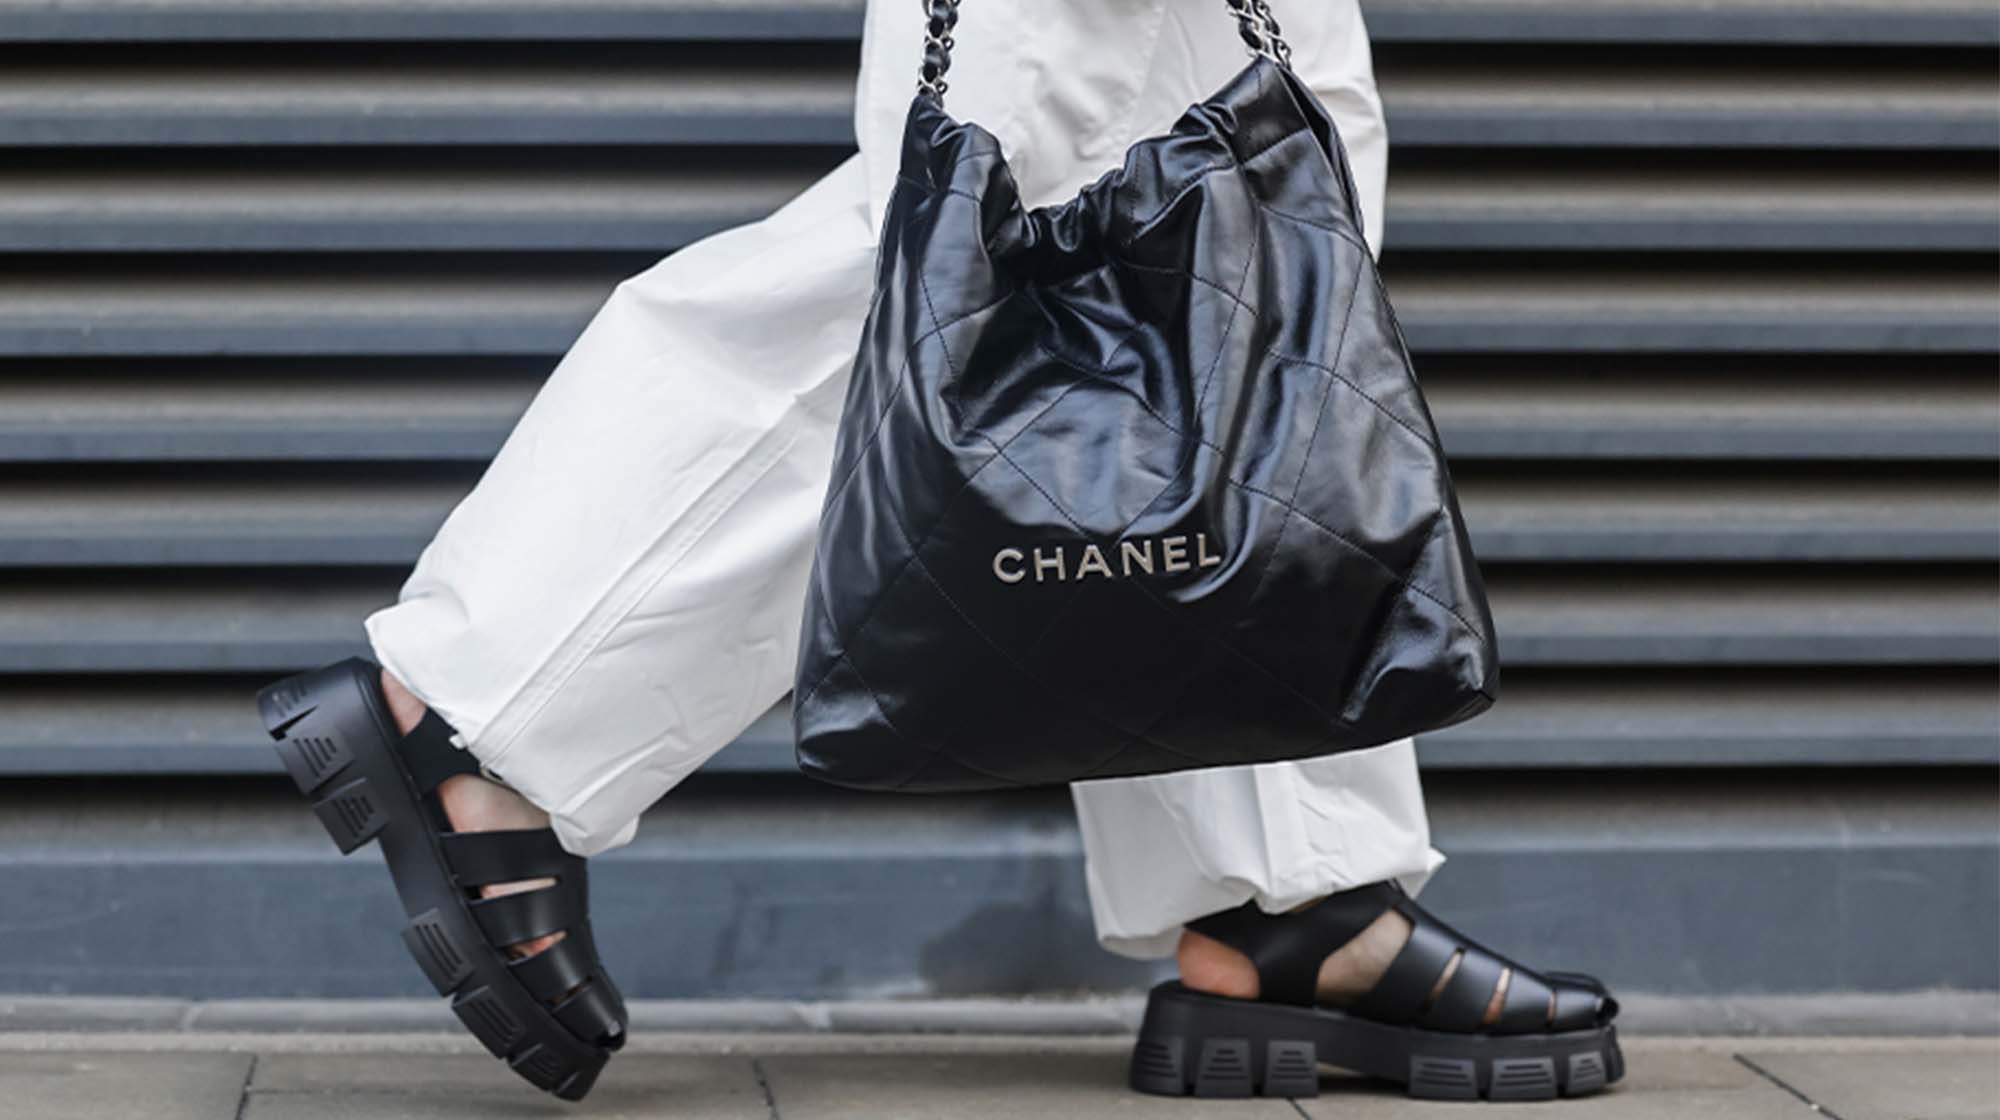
[{"x1": 1132, "y1": 982, "x2": 1624, "y2": 1100}]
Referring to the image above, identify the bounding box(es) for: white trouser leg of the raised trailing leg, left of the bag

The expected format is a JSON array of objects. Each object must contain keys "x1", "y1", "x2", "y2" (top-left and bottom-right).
[{"x1": 368, "y1": 160, "x2": 874, "y2": 856}]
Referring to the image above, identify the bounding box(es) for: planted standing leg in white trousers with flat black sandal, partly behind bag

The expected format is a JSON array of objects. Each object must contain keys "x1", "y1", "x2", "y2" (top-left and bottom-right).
[{"x1": 1074, "y1": 0, "x2": 1622, "y2": 1098}]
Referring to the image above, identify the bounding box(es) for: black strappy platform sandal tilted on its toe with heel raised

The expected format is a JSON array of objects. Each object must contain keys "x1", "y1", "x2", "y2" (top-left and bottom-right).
[{"x1": 258, "y1": 658, "x2": 626, "y2": 1100}]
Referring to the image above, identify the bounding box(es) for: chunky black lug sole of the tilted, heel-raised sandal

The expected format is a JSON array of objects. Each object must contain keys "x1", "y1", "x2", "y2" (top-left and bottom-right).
[{"x1": 258, "y1": 660, "x2": 610, "y2": 1100}]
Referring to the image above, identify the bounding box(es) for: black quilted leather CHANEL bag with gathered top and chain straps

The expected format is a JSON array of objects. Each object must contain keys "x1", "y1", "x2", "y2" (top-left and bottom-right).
[{"x1": 792, "y1": 0, "x2": 1496, "y2": 790}]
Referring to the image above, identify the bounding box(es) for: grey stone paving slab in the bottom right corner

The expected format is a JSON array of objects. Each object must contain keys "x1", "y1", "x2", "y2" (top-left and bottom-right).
[{"x1": 1748, "y1": 1042, "x2": 2000, "y2": 1120}]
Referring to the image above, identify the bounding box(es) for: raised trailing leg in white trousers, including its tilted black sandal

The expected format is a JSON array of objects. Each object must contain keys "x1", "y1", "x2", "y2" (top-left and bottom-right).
[{"x1": 258, "y1": 144, "x2": 874, "y2": 1098}]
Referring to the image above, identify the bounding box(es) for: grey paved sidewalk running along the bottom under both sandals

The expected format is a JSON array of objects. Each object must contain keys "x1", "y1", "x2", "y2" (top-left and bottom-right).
[{"x1": 0, "y1": 1032, "x2": 2000, "y2": 1120}]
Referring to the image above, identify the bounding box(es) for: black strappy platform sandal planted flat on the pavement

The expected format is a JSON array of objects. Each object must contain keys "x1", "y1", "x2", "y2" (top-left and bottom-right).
[{"x1": 1132, "y1": 882, "x2": 1624, "y2": 1100}]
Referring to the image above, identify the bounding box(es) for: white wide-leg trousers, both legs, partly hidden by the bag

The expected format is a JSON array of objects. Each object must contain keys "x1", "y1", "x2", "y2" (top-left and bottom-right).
[{"x1": 368, "y1": 0, "x2": 1442, "y2": 956}]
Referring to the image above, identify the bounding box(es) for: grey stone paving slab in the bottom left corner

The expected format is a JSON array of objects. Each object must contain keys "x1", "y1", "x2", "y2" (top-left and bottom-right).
[{"x1": 0, "y1": 1052, "x2": 252, "y2": 1120}]
